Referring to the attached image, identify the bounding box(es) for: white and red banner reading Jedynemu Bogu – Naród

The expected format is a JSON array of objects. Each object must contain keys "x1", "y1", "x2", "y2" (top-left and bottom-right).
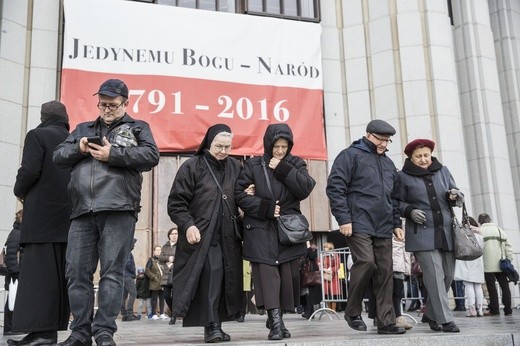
[{"x1": 62, "y1": 0, "x2": 326, "y2": 159}]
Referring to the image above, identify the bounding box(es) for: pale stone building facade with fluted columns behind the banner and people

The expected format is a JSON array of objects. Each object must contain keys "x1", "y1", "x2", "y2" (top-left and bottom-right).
[{"x1": 0, "y1": 0, "x2": 520, "y2": 261}]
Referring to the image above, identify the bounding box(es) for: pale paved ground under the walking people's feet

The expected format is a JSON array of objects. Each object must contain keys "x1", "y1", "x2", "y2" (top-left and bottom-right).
[{"x1": 0, "y1": 310, "x2": 520, "y2": 346}]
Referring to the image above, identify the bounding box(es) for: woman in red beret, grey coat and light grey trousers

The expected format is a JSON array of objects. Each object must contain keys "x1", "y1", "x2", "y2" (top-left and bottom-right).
[{"x1": 398, "y1": 139, "x2": 464, "y2": 332}]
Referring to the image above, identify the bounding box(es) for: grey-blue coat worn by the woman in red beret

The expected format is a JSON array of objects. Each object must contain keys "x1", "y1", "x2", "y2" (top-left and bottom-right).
[{"x1": 398, "y1": 157, "x2": 457, "y2": 252}]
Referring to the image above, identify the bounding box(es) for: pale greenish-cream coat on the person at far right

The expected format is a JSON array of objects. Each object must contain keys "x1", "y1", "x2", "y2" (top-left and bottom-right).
[{"x1": 479, "y1": 222, "x2": 513, "y2": 273}]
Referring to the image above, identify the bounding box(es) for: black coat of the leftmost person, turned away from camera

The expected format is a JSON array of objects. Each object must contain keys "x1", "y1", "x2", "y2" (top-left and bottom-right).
[{"x1": 14, "y1": 117, "x2": 71, "y2": 245}]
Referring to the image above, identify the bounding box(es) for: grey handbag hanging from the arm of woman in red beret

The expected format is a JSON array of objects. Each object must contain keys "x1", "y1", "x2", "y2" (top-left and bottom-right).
[{"x1": 450, "y1": 203, "x2": 483, "y2": 261}]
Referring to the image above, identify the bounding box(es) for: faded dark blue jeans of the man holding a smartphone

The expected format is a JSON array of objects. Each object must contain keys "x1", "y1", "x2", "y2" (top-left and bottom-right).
[{"x1": 66, "y1": 212, "x2": 136, "y2": 340}]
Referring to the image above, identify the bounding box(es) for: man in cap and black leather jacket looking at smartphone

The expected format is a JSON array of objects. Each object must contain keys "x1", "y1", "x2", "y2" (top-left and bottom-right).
[{"x1": 53, "y1": 79, "x2": 159, "y2": 346}]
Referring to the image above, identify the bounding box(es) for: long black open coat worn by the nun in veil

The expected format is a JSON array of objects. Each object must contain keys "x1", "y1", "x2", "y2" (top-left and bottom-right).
[{"x1": 168, "y1": 151, "x2": 243, "y2": 320}]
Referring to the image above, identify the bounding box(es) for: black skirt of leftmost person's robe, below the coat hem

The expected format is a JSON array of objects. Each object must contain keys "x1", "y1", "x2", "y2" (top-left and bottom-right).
[{"x1": 12, "y1": 243, "x2": 70, "y2": 333}]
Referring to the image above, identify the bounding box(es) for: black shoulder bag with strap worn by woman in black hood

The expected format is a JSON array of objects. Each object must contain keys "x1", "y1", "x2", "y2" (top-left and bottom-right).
[{"x1": 262, "y1": 160, "x2": 312, "y2": 245}]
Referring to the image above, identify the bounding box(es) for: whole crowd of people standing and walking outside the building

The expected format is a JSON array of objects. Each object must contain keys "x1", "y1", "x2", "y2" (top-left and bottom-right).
[{"x1": 4, "y1": 79, "x2": 513, "y2": 346}]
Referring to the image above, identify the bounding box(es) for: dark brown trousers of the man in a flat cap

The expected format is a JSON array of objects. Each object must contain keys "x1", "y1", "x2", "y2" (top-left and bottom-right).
[{"x1": 345, "y1": 232, "x2": 395, "y2": 326}]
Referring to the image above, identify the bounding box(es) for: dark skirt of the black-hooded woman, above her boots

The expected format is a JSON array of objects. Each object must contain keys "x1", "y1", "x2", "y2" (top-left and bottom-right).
[{"x1": 251, "y1": 259, "x2": 300, "y2": 311}]
